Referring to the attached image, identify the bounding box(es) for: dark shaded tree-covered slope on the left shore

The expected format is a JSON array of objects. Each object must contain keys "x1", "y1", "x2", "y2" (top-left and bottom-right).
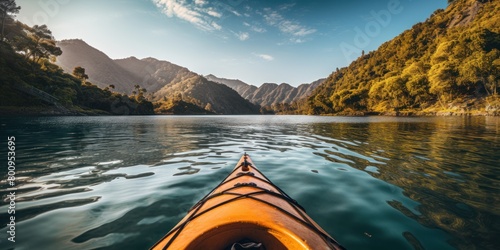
[{"x1": 0, "y1": 0, "x2": 154, "y2": 115}]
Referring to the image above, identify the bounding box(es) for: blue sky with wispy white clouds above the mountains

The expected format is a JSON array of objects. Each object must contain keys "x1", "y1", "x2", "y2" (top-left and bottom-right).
[{"x1": 17, "y1": 0, "x2": 447, "y2": 86}]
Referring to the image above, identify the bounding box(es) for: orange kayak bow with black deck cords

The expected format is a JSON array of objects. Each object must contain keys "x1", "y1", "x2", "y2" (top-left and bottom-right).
[{"x1": 152, "y1": 154, "x2": 344, "y2": 249}]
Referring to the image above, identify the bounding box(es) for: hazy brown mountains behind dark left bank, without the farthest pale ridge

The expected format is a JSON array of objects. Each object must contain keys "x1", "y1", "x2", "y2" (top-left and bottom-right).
[{"x1": 56, "y1": 39, "x2": 259, "y2": 114}]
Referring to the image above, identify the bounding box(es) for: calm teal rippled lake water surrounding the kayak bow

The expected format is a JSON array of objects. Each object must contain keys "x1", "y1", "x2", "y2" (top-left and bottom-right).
[{"x1": 0, "y1": 116, "x2": 500, "y2": 249}]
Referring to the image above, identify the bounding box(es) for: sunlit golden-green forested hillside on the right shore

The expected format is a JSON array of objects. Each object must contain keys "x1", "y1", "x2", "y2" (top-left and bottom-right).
[{"x1": 302, "y1": 0, "x2": 500, "y2": 114}]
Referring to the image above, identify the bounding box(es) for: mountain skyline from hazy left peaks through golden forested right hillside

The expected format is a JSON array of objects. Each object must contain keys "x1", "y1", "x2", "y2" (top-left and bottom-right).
[{"x1": 34, "y1": 0, "x2": 500, "y2": 115}]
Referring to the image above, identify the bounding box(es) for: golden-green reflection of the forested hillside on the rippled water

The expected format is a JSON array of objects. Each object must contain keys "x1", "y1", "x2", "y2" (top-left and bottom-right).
[{"x1": 312, "y1": 117, "x2": 500, "y2": 249}]
